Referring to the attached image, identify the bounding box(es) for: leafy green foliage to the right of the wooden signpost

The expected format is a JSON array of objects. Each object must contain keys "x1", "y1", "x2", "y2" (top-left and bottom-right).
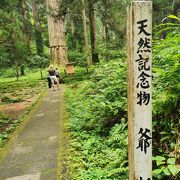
[{"x1": 153, "y1": 16, "x2": 180, "y2": 179}]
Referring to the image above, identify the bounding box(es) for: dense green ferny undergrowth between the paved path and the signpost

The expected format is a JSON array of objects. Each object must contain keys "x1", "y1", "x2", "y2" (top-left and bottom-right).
[{"x1": 66, "y1": 59, "x2": 128, "y2": 179}]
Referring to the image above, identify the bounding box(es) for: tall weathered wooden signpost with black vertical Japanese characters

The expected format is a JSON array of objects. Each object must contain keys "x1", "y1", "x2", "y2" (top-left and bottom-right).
[{"x1": 127, "y1": 0, "x2": 152, "y2": 180}]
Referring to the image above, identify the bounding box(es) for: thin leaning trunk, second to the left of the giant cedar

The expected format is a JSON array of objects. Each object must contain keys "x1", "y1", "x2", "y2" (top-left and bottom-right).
[{"x1": 19, "y1": 0, "x2": 31, "y2": 52}]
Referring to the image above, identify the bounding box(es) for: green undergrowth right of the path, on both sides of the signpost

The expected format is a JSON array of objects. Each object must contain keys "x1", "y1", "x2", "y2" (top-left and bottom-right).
[{"x1": 66, "y1": 19, "x2": 180, "y2": 180}]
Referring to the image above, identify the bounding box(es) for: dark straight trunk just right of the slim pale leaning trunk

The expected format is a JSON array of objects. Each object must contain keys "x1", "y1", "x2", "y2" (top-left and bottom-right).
[{"x1": 89, "y1": 0, "x2": 99, "y2": 63}]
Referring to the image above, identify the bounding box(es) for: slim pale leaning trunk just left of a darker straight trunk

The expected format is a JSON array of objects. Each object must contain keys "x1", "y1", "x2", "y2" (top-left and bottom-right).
[{"x1": 82, "y1": 0, "x2": 92, "y2": 66}]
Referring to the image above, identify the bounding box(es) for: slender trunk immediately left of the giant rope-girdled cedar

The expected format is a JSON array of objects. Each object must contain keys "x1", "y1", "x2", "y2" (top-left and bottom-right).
[{"x1": 32, "y1": 0, "x2": 43, "y2": 55}]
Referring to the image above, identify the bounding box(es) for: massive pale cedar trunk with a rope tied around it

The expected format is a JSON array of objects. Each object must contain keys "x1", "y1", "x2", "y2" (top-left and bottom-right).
[{"x1": 46, "y1": 0, "x2": 68, "y2": 66}]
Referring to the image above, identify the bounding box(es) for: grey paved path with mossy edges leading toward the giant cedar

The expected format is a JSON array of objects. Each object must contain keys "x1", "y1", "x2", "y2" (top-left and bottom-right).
[{"x1": 0, "y1": 90, "x2": 62, "y2": 180}]
